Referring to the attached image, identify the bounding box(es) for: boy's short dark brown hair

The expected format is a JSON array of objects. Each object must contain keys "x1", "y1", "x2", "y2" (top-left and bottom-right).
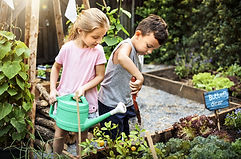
[{"x1": 136, "y1": 14, "x2": 168, "y2": 45}]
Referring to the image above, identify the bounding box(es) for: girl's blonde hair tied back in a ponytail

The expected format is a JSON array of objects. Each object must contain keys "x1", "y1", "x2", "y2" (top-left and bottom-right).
[{"x1": 67, "y1": 8, "x2": 110, "y2": 41}]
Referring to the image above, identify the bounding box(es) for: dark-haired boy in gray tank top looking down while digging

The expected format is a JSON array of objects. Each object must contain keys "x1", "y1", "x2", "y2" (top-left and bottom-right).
[{"x1": 98, "y1": 15, "x2": 168, "y2": 139}]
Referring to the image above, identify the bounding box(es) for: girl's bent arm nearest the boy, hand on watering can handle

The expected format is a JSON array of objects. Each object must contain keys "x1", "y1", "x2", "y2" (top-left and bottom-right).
[{"x1": 76, "y1": 64, "x2": 105, "y2": 96}]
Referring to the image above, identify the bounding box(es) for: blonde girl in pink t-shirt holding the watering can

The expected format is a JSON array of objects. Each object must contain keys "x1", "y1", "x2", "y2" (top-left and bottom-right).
[{"x1": 50, "y1": 8, "x2": 109, "y2": 154}]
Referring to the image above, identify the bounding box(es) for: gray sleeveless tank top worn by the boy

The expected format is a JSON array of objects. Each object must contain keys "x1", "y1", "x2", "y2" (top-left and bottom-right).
[{"x1": 98, "y1": 38, "x2": 141, "y2": 107}]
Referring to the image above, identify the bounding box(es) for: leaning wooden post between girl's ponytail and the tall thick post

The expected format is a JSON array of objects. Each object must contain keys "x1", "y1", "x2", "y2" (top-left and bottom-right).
[{"x1": 53, "y1": 0, "x2": 64, "y2": 48}]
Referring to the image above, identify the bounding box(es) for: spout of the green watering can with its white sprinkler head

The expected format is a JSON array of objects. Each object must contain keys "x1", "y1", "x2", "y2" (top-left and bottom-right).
[{"x1": 84, "y1": 102, "x2": 126, "y2": 131}]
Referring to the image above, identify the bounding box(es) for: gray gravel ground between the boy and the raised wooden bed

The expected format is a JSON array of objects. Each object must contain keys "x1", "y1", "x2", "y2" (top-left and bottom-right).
[{"x1": 131, "y1": 85, "x2": 213, "y2": 134}]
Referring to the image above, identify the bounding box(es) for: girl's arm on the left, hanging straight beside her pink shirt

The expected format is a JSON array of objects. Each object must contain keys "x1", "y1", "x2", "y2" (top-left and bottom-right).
[{"x1": 49, "y1": 62, "x2": 62, "y2": 103}]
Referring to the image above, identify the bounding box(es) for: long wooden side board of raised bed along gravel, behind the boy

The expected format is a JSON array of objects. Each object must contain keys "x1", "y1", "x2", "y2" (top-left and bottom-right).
[{"x1": 143, "y1": 73, "x2": 205, "y2": 104}]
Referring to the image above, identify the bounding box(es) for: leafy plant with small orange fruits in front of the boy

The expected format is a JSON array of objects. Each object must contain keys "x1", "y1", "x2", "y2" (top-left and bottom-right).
[{"x1": 81, "y1": 122, "x2": 150, "y2": 159}]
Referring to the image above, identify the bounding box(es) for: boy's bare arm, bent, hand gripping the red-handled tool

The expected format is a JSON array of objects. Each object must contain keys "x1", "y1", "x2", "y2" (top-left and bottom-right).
[{"x1": 114, "y1": 43, "x2": 144, "y2": 94}]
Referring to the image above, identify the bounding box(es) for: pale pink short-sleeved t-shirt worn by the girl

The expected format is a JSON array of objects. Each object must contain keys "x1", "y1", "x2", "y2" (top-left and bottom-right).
[{"x1": 55, "y1": 41, "x2": 106, "y2": 113}]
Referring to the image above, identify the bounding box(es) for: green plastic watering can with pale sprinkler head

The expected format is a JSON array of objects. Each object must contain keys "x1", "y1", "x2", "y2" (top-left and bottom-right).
[{"x1": 49, "y1": 94, "x2": 126, "y2": 132}]
